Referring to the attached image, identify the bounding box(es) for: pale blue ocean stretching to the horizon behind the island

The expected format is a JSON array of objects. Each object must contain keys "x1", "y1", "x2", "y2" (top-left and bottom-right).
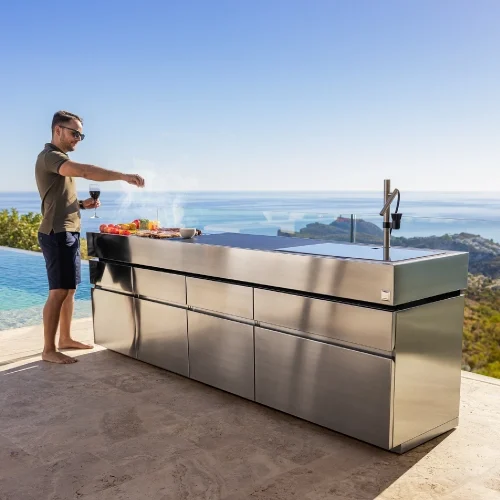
[{"x1": 0, "y1": 190, "x2": 500, "y2": 243}]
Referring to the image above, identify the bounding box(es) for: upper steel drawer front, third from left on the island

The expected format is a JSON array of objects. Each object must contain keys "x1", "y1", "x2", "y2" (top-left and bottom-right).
[{"x1": 186, "y1": 278, "x2": 253, "y2": 319}]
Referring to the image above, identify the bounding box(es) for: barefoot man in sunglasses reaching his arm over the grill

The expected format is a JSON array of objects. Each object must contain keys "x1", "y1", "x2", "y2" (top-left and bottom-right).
[{"x1": 35, "y1": 111, "x2": 144, "y2": 363}]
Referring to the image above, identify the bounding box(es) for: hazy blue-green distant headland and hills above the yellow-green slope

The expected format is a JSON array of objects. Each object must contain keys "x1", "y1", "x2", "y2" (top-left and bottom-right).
[{"x1": 278, "y1": 217, "x2": 500, "y2": 279}]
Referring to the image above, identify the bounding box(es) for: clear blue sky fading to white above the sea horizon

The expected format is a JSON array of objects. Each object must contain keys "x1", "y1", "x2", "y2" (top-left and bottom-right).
[{"x1": 0, "y1": 0, "x2": 500, "y2": 191}]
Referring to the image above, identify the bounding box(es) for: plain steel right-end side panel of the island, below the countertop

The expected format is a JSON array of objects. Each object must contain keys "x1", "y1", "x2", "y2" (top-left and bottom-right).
[{"x1": 394, "y1": 296, "x2": 464, "y2": 446}]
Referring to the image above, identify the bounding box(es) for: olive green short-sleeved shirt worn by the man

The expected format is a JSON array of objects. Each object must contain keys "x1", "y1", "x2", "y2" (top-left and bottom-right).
[{"x1": 35, "y1": 143, "x2": 81, "y2": 234}]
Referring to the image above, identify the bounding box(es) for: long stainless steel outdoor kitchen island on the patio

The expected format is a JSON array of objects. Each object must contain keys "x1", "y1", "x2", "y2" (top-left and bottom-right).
[{"x1": 87, "y1": 233, "x2": 468, "y2": 453}]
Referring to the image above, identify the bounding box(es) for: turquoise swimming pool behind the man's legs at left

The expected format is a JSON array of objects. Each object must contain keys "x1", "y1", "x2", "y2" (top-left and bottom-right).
[{"x1": 0, "y1": 247, "x2": 92, "y2": 330}]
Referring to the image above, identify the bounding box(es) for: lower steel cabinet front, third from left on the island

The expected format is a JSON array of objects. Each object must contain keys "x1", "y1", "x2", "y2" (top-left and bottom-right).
[{"x1": 188, "y1": 311, "x2": 254, "y2": 400}]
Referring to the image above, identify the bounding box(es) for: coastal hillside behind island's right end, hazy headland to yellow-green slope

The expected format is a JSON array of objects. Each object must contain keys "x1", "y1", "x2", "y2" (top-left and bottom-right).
[{"x1": 278, "y1": 218, "x2": 500, "y2": 378}]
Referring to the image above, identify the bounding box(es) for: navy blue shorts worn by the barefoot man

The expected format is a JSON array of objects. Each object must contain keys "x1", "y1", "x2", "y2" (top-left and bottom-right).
[{"x1": 38, "y1": 232, "x2": 82, "y2": 290}]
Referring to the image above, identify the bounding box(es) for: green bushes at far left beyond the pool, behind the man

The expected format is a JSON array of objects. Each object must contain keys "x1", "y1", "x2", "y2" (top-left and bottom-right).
[{"x1": 0, "y1": 208, "x2": 88, "y2": 259}]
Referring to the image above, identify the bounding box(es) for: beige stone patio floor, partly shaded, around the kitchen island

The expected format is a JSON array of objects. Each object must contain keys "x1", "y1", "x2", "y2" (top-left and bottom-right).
[{"x1": 0, "y1": 320, "x2": 500, "y2": 500}]
